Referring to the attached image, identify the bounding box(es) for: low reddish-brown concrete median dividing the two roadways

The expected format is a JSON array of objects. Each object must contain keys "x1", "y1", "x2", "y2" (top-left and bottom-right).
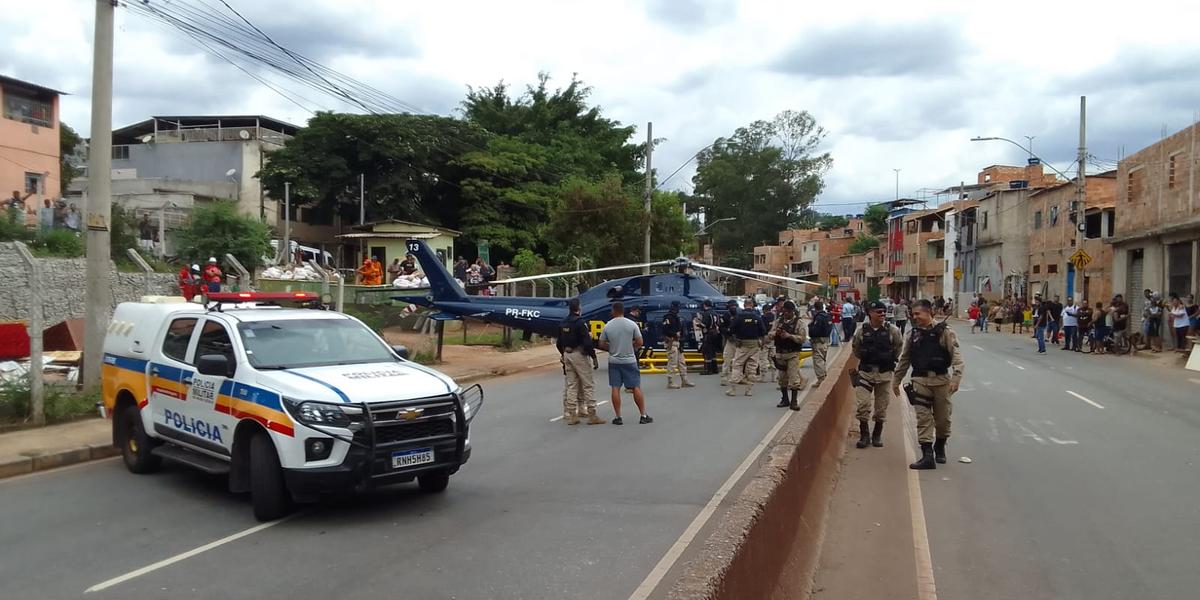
[{"x1": 668, "y1": 352, "x2": 853, "y2": 600}]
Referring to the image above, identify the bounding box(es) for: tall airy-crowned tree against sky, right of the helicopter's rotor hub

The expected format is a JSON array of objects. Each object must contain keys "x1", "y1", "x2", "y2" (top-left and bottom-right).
[{"x1": 690, "y1": 110, "x2": 833, "y2": 266}]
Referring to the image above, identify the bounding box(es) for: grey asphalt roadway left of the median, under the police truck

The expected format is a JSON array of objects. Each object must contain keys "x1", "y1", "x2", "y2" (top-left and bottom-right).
[{"x1": 0, "y1": 355, "x2": 825, "y2": 600}]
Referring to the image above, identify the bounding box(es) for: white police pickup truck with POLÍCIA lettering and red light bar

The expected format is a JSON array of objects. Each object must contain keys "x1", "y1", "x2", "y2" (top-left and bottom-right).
[{"x1": 102, "y1": 292, "x2": 484, "y2": 521}]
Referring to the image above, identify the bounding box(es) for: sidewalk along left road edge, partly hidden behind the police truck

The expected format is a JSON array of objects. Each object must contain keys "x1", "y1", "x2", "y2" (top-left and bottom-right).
[{"x1": 0, "y1": 344, "x2": 559, "y2": 479}]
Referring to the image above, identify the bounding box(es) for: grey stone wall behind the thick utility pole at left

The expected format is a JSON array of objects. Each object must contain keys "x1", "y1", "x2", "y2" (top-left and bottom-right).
[{"x1": 0, "y1": 242, "x2": 179, "y2": 328}]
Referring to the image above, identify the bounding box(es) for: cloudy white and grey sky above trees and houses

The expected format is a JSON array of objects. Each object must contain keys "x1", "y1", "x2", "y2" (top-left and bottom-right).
[{"x1": 0, "y1": 0, "x2": 1200, "y2": 212}]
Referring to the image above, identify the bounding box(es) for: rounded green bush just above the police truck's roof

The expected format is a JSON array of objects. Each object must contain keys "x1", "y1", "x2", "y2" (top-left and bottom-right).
[{"x1": 176, "y1": 200, "x2": 271, "y2": 270}]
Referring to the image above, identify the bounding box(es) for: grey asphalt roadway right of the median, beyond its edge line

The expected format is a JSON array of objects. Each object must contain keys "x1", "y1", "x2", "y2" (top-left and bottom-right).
[{"x1": 920, "y1": 325, "x2": 1200, "y2": 600}]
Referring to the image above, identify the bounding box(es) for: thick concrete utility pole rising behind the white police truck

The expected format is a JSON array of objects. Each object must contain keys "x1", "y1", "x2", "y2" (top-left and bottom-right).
[{"x1": 82, "y1": 0, "x2": 115, "y2": 391}]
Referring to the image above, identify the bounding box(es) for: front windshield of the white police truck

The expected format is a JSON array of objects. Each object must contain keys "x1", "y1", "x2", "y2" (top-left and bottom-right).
[{"x1": 238, "y1": 319, "x2": 396, "y2": 368}]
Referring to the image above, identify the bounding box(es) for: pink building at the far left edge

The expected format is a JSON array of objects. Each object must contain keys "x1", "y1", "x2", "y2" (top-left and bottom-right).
[{"x1": 0, "y1": 76, "x2": 62, "y2": 211}]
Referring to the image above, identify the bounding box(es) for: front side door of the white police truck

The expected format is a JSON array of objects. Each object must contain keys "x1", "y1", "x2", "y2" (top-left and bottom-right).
[{"x1": 186, "y1": 317, "x2": 238, "y2": 456}]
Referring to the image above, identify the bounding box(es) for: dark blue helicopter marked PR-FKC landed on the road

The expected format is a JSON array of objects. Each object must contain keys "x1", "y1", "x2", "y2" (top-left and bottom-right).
[{"x1": 394, "y1": 240, "x2": 820, "y2": 362}]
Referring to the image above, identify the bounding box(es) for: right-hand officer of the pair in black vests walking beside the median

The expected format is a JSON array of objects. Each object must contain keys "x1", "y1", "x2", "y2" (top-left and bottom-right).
[{"x1": 892, "y1": 300, "x2": 962, "y2": 469}]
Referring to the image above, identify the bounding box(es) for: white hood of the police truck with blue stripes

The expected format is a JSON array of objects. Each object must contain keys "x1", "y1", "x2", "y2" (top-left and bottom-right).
[{"x1": 258, "y1": 361, "x2": 458, "y2": 402}]
